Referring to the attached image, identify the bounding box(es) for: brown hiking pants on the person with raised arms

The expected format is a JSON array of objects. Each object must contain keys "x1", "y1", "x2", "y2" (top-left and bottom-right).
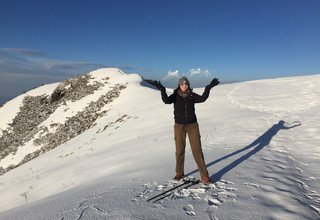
[{"x1": 174, "y1": 123, "x2": 209, "y2": 177}]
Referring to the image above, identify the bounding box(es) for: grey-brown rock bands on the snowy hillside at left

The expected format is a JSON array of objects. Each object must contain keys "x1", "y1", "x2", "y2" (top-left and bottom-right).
[{"x1": 0, "y1": 75, "x2": 126, "y2": 175}]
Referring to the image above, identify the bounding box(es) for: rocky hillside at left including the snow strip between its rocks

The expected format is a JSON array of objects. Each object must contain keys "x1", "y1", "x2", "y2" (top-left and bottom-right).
[{"x1": 0, "y1": 70, "x2": 132, "y2": 173}]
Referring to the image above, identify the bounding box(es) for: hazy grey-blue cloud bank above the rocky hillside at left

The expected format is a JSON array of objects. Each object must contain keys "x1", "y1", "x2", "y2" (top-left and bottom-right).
[{"x1": 0, "y1": 48, "x2": 106, "y2": 102}]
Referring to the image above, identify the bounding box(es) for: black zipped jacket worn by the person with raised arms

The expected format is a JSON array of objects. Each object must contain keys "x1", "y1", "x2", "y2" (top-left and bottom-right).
[{"x1": 161, "y1": 86, "x2": 210, "y2": 124}]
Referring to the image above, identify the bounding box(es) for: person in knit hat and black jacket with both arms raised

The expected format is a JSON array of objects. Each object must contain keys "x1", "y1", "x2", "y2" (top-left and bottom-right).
[{"x1": 149, "y1": 77, "x2": 220, "y2": 184}]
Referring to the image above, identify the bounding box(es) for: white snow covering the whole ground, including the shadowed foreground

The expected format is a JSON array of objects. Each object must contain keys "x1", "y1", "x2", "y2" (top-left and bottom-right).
[{"x1": 0, "y1": 68, "x2": 320, "y2": 220}]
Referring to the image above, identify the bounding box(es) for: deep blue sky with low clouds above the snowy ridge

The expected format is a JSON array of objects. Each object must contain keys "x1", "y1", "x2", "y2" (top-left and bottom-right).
[{"x1": 0, "y1": 0, "x2": 320, "y2": 102}]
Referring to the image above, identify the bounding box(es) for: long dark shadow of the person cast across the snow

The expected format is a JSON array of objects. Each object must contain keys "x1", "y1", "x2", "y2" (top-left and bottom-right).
[{"x1": 187, "y1": 120, "x2": 301, "y2": 182}]
